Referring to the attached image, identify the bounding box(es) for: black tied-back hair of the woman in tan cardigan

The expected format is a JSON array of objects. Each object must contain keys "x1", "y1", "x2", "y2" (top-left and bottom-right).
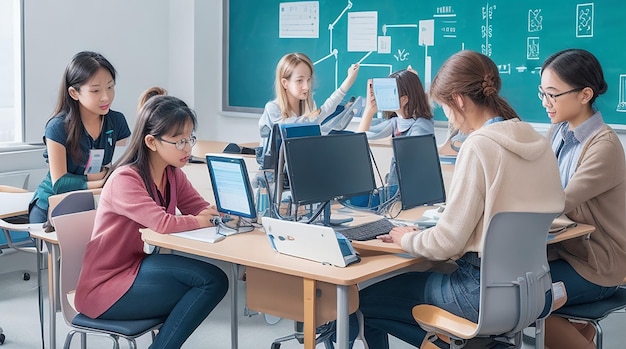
[{"x1": 541, "y1": 48, "x2": 608, "y2": 105}]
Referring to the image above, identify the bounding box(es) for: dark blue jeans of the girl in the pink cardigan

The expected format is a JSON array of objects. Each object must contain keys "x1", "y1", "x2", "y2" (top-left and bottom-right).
[{"x1": 100, "y1": 254, "x2": 228, "y2": 349}]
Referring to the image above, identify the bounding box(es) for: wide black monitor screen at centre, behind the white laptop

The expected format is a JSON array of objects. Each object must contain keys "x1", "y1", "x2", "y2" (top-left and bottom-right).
[{"x1": 284, "y1": 133, "x2": 376, "y2": 204}]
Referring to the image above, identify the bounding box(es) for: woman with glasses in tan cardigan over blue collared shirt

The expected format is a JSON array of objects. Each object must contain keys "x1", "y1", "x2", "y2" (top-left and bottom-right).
[{"x1": 539, "y1": 49, "x2": 626, "y2": 349}]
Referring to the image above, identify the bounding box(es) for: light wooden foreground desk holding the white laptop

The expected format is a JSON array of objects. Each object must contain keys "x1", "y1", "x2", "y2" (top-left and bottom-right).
[{"x1": 141, "y1": 229, "x2": 427, "y2": 349}]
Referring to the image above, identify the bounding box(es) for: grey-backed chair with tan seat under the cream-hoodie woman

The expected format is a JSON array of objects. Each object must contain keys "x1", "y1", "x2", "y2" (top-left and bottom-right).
[{"x1": 413, "y1": 212, "x2": 558, "y2": 349}]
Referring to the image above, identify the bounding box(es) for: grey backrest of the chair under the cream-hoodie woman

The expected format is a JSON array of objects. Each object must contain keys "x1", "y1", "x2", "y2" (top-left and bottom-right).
[{"x1": 477, "y1": 212, "x2": 558, "y2": 335}]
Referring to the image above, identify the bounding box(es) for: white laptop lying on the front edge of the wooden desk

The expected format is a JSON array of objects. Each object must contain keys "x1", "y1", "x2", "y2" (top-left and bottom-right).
[{"x1": 262, "y1": 217, "x2": 360, "y2": 267}]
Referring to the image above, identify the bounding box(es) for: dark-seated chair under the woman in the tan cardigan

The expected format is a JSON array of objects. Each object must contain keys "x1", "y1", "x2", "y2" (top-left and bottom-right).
[{"x1": 552, "y1": 279, "x2": 626, "y2": 349}]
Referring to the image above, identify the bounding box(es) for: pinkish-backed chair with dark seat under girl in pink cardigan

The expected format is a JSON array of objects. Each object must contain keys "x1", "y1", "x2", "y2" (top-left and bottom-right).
[{"x1": 52, "y1": 210, "x2": 165, "y2": 349}]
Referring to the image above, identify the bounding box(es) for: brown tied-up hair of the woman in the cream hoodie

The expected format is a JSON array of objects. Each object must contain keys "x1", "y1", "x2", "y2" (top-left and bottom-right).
[{"x1": 430, "y1": 50, "x2": 520, "y2": 120}]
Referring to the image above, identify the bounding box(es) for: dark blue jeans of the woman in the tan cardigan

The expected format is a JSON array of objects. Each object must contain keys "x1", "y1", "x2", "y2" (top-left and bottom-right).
[{"x1": 549, "y1": 259, "x2": 617, "y2": 305}]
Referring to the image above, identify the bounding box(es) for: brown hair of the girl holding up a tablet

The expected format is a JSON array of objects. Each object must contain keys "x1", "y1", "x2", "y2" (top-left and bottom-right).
[{"x1": 384, "y1": 69, "x2": 433, "y2": 119}]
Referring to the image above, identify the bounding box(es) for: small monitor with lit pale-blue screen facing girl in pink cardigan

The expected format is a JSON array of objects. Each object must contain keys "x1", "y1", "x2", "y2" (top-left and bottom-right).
[{"x1": 206, "y1": 154, "x2": 256, "y2": 232}]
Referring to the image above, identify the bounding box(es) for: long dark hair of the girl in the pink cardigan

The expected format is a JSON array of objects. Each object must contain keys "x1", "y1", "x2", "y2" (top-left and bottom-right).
[{"x1": 109, "y1": 95, "x2": 198, "y2": 199}]
